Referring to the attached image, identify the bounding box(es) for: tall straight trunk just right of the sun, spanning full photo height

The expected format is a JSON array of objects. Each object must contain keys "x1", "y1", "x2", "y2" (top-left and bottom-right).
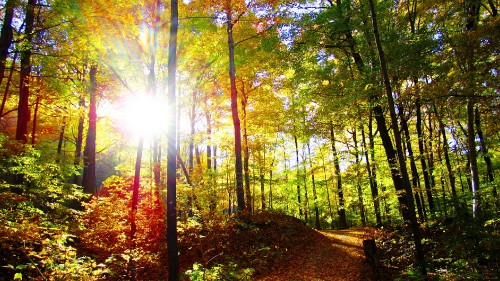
[{"x1": 167, "y1": 0, "x2": 180, "y2": 276}]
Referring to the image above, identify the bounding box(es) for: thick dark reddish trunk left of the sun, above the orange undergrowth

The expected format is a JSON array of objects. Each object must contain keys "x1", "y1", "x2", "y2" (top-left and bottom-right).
[{"x1": 82, "y1": 65, "x2": 97, "y2": 194}]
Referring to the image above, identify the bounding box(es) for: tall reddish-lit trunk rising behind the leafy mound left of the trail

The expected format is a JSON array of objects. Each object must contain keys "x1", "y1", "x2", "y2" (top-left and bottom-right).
[{"x1": 226, "y1": 9, "x2": 245, "y2": 212}]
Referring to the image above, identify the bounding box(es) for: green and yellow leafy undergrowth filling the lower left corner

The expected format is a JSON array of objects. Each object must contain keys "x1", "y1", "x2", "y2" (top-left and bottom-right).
[{"x1": 0, "y1": 136, "x2": 100, "y2": 280}]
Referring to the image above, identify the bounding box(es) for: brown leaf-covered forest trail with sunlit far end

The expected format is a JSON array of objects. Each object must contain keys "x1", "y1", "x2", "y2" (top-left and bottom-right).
[{"x1": 258, "y1": 228, "x2": 375, "y2": 281}]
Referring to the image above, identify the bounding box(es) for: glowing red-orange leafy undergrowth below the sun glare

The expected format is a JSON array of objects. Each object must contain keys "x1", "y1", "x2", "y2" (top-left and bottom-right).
[{"x1": 80, "y1": 176, "x2": 167, "y2": 280}]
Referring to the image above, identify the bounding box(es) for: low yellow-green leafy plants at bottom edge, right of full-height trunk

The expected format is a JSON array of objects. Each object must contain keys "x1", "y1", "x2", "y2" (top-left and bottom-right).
[{"x1": 184, "y1": 262, "x2": 255, "y2": 281}]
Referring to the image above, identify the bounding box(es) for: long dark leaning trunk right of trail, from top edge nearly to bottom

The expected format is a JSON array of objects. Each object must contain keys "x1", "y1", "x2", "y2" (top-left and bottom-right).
[{"x1": 369, "y1": 0, "x2": 427, "y2": 272}]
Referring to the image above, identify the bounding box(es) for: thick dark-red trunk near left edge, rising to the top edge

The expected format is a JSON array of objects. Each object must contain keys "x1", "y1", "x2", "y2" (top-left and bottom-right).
[{"x1": 16, "y1": 0, "x2": 36, "y2": 143}]
